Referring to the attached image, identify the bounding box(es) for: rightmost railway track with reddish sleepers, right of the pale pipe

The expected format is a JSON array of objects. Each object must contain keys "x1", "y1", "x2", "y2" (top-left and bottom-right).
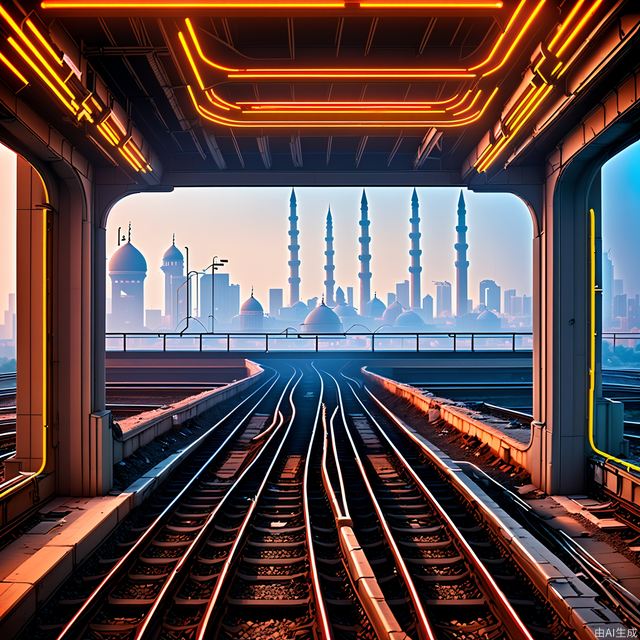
[{"x1": 322, "y1": 368, "x2": 572, "y2": 639}]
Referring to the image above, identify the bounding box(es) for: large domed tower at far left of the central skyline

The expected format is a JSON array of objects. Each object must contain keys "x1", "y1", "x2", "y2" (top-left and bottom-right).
[{"x1": 109, "y1": 225, "x2": 147, "y2": 332}]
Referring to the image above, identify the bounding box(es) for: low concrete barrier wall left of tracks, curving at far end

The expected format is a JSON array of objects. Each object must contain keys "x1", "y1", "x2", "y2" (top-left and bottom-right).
[{"x1": 113, "y1": 360, "x2": 264, "y2": 464}]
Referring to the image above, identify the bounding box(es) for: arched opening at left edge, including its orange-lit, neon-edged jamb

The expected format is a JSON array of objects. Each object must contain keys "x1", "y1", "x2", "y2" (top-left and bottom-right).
[{"x1": 0, "y1": 146, "x2": 52, "y2": 508}]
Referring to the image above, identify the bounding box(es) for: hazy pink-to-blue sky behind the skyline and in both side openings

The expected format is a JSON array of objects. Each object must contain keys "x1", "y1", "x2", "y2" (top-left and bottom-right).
[{"x1": 0, "y1": 143, "x2": 640, "y2": 313}]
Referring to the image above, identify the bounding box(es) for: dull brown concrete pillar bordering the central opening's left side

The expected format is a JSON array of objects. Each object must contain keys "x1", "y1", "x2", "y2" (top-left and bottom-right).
[{"x1": 52, "y1": 175, "x2": 113, "y2": 496}]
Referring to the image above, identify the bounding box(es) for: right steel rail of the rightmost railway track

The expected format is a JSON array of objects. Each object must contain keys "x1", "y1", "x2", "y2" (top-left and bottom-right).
[{"x1": 340, "y1": 372, "x2": 533, "y2": 640}]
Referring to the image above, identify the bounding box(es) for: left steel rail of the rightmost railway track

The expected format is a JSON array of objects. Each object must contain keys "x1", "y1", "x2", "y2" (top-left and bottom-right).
[{"x1": 324, "y1": 371, "x2": 436, "y2": 640}]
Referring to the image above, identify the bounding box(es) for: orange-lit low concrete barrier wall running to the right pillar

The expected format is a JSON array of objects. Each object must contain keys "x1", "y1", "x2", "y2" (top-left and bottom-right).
[{"x1": 361, "y1": 367, "x2": 540, "y2": 476}]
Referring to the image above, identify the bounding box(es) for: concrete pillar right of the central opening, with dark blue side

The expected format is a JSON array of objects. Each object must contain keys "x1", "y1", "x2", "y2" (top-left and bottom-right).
[{"x1": 533, "y1": 163, "x2": 600, "y2": 494}]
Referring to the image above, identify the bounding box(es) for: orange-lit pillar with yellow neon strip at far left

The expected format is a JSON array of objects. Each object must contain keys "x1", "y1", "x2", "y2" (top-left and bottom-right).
[{"x1": 5, "y1": 156, "x2": 52, "y2": 478}]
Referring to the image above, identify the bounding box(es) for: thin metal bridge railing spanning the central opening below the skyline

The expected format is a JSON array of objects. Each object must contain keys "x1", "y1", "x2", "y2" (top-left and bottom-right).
[{"x1": 106, "y1": 331, "x2": 533, "y2": 353}]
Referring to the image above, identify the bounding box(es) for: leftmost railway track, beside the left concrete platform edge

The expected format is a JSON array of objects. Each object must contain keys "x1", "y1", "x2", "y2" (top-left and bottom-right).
[{"x1": 23, "y1": 362, "x2": 300, "y2": 640}]
